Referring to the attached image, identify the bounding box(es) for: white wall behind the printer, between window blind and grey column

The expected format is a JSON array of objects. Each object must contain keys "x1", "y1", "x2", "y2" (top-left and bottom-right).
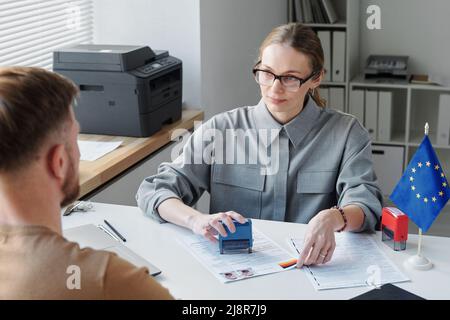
[{"x1": 94, "y1": 0, "x2": 201, "y2": 108}]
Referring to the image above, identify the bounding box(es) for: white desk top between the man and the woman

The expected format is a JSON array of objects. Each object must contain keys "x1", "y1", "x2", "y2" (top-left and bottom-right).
[{"x1": 62, "y1": 203, "x2": 450, "y2": 300}]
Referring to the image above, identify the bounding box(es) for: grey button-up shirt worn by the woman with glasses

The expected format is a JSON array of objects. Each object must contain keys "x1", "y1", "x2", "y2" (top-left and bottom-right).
[{"x1": 136, "y1": 98, "x2": 382, "y2": 231}]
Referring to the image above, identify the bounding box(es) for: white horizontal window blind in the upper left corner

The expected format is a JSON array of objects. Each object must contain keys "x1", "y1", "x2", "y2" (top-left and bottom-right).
[{"x1": 0, "y1": 0, "x2": 93, "y2": 70}]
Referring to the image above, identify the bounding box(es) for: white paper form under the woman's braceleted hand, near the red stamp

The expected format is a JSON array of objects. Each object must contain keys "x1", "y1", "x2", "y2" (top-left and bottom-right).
[{"x1": 288, "y1": 232, "x2": 409, "y2": 290}]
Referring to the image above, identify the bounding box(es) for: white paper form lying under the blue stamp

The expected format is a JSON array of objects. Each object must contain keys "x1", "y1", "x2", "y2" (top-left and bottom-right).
[{"x1": 179, "y1": 227, "x2": 297, "y2": 283}]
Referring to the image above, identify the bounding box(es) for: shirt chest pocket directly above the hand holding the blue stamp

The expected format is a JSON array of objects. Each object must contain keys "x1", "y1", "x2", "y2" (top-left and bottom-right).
[{"x1": 210, "y1": 164, "x2": 266, "y2": 218}]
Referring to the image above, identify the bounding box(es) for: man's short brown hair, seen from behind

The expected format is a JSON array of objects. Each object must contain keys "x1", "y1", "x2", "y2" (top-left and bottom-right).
[{"x1": 0, "y1": 67, "x2": 78, "y2": 172}]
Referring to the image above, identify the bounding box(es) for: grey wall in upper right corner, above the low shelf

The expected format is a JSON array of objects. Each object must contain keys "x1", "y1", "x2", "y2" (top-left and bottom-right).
[{"x1": 360, "y1": 0, "x2": 450, "y2": 75}]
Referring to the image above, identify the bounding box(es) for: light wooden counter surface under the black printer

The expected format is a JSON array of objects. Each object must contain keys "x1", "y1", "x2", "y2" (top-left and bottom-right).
[{"x1": 78, "y1": 109, "x2": 203, "y2": 198}]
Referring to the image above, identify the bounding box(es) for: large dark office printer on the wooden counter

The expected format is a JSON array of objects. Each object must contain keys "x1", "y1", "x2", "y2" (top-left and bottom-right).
[{"x1": 53, "y1": 44, "x2": 182, "y2": 137}]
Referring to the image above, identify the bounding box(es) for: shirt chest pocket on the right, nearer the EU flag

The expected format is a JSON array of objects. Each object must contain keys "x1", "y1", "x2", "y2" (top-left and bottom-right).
[{"x1": 297, "y1": 170, "x2": 337, "y2": 194}]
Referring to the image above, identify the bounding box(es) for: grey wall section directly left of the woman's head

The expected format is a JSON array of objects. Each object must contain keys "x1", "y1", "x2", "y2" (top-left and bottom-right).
[{"x1": 200, "y1": 0, "x2": 287, "y2": 118}]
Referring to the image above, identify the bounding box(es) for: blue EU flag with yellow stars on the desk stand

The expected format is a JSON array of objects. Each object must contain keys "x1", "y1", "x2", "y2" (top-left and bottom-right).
[{"x1": 390, "y1": 135, "x2": 450, "y2": 232}]
